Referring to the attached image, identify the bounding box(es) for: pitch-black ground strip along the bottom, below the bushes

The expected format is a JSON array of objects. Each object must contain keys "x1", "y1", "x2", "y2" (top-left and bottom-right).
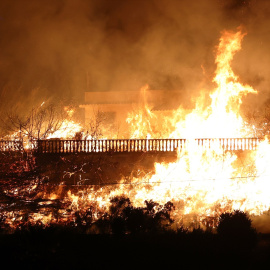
[{"x1": 0, "y1": 231, "x2": 270, "y2": 269}]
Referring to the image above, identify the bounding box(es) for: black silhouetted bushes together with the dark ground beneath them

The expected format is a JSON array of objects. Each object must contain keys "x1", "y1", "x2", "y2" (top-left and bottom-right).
[{"x1": 0, "y1": 204, "x2": 264, "y2": 269}]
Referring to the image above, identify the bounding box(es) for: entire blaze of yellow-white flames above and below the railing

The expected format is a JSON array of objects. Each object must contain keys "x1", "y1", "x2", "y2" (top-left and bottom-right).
[{"x1": 3, "y1": 26, "x2": 270, "y2": 231}]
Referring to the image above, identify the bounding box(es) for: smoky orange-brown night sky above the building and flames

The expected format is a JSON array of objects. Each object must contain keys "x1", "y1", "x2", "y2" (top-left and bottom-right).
[{"x1": 0, "y1": 0, "x2": 270, "y2": 113}]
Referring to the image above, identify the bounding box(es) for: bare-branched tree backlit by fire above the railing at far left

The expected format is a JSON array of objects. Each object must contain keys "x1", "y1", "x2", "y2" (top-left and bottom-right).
[{"x1": 1, "y1": 102, "x2": 82, "y2": 147}]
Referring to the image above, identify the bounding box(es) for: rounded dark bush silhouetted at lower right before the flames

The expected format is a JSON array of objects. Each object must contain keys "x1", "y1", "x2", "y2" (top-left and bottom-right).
[{"x1": 217, "y1": 210, "x2": 257, "y2": 250}]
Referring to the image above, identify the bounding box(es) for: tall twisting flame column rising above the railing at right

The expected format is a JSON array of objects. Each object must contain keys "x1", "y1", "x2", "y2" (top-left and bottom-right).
[{"x1": 171, "y1": 29, "x2": 257, "y2": 138}]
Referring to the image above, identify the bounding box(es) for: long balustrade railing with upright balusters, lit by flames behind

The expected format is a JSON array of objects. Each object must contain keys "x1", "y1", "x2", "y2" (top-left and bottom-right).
[{"x1": 36, "y1": 138, "x2": 260, "y2": 153}]
